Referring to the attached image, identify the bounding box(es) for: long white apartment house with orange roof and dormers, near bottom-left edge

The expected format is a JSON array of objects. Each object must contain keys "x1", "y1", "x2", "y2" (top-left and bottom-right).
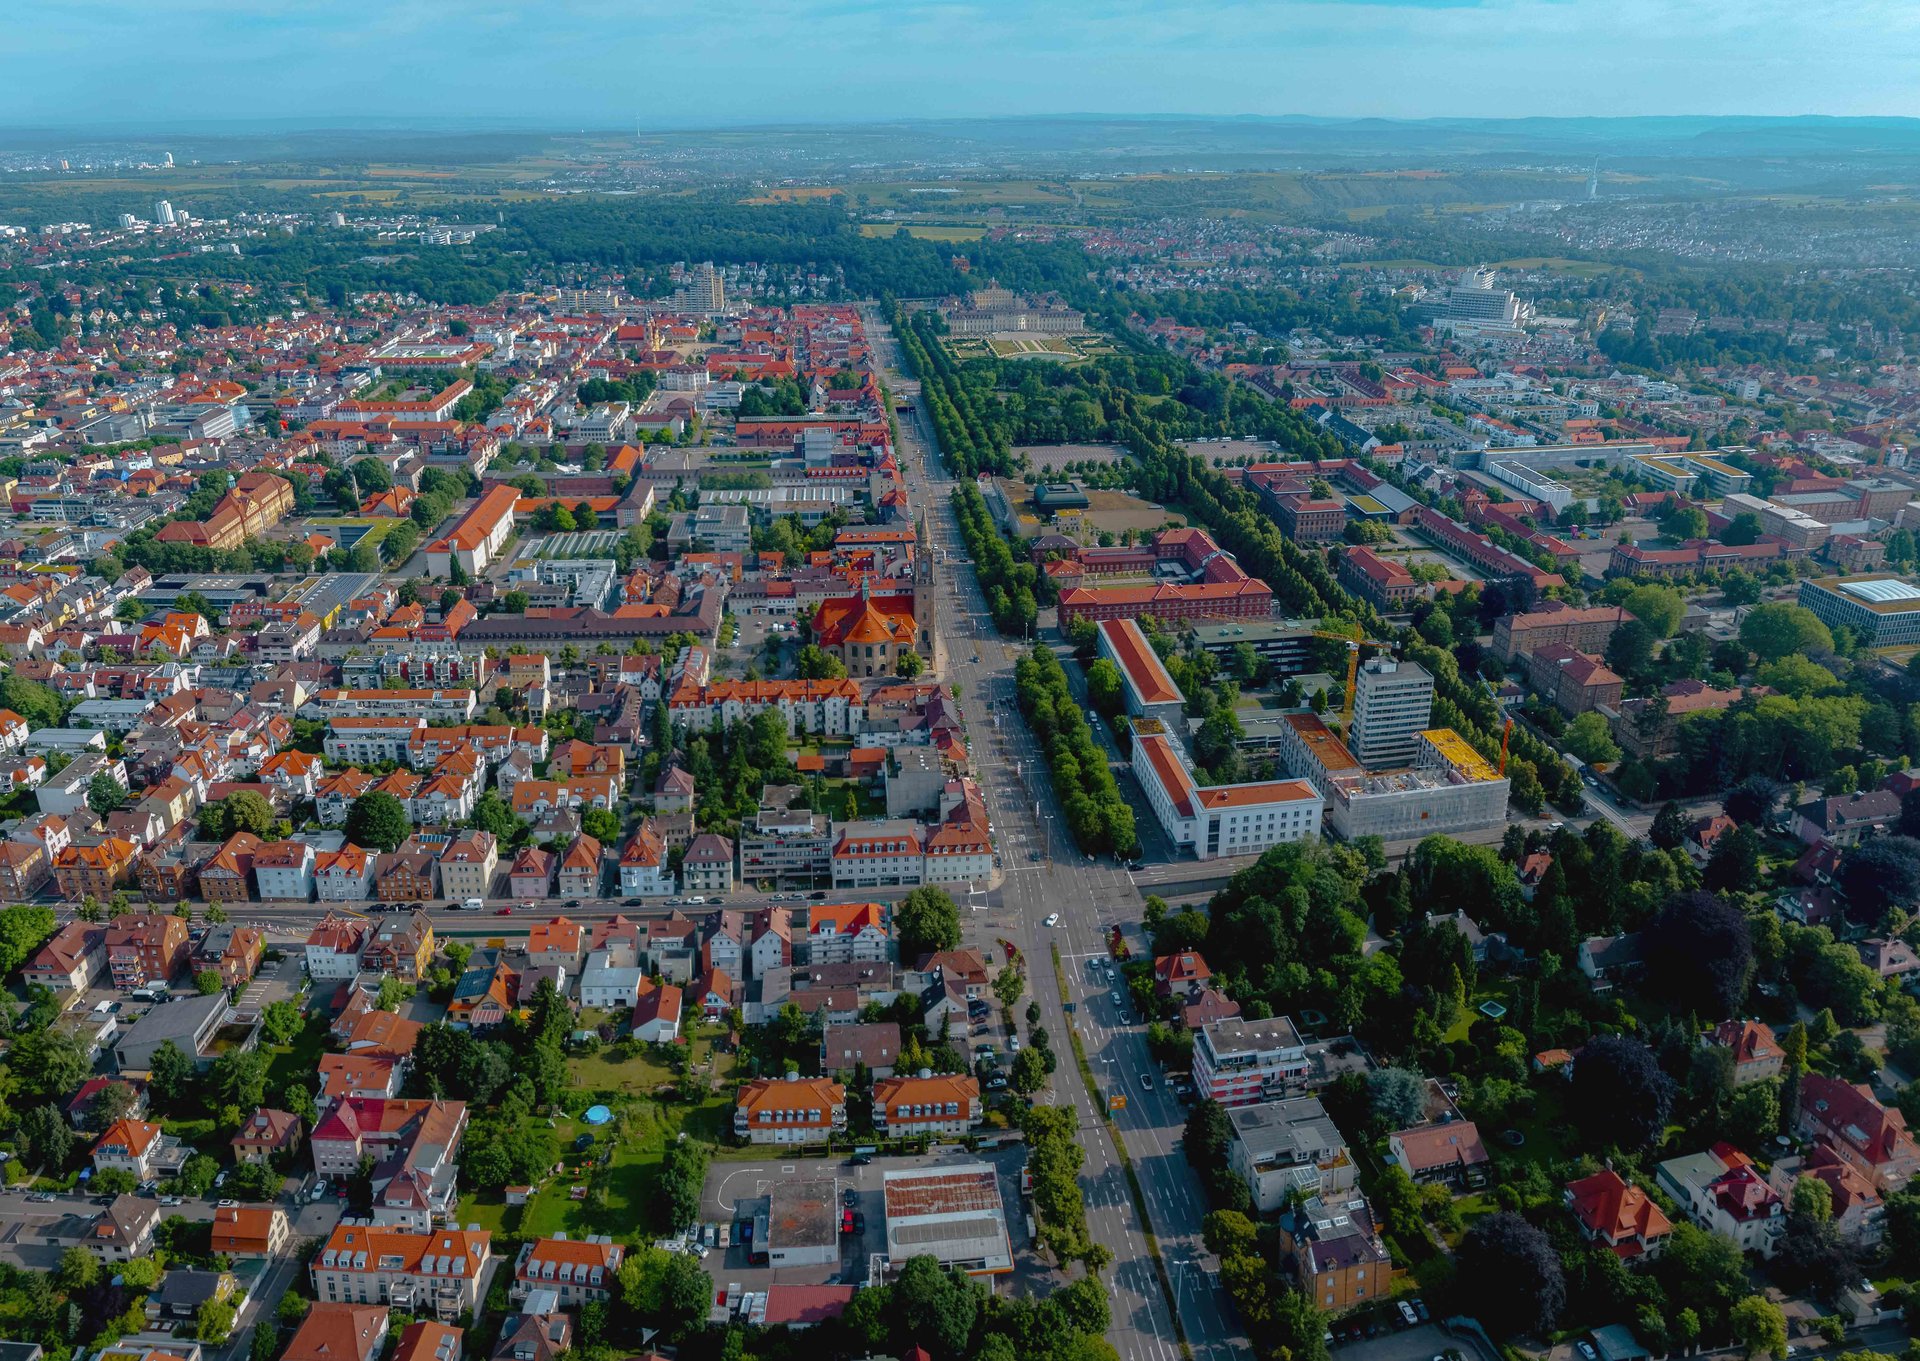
[{"x1": 309, "y1": 1223, "x2": 492, "y2": 1319}]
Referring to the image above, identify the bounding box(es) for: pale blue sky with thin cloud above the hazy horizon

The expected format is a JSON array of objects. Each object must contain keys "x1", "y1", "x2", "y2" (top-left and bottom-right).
[{"x1": 15, "y1": 0, "x2": 1920, "y2": 129}]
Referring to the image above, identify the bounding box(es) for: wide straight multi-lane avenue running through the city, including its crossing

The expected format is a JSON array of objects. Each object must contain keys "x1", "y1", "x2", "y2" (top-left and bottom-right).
[{"x1": 866, "y1": 311, "x2": 1248, "y2": 1361}]
